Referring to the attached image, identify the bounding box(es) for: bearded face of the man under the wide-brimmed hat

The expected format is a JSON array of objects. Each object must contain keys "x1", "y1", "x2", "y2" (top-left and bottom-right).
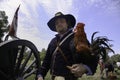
[{"x1": 55, "y1": 18, "x2": 68, "y2": 34}]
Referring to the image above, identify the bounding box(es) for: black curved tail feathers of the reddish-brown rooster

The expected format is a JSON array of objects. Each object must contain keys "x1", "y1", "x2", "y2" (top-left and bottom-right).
[{"x1": 90, "y1": 32, "x2": 115, "y2": 61}]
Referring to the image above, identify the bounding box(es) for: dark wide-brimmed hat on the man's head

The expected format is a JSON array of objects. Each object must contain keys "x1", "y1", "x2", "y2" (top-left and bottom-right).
[{"x1": 47, "y1": 12, "x2": 76, "y2": 32}]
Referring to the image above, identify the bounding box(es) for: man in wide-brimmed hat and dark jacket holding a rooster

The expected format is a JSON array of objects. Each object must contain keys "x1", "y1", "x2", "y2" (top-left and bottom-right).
[{"x1": 38, "y1": 12, "x2": 98, "y2": 80}]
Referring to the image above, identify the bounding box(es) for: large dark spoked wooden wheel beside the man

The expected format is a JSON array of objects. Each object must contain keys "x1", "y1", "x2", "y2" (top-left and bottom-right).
[{"x1": 0, "y1": 39, "x2": 41, "y2": 80}]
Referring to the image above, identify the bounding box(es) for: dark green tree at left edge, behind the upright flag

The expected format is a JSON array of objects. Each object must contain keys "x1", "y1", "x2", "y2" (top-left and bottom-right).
[{"x1": 0, "y1": 11, "x2": 8, "y2": 42}]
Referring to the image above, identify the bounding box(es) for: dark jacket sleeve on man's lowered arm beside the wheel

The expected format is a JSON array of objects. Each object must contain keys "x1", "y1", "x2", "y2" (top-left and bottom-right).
[{"x1": 38, "y1": 40, "x2": 52, "y2": 78}]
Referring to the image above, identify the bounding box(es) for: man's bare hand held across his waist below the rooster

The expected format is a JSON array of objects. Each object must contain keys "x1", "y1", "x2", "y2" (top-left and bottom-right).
[{"x1": 67, "y1": 64, "x2": 87, "y2": 77}]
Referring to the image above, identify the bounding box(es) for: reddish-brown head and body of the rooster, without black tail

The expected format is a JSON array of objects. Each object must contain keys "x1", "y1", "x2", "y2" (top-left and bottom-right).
[{"x1": 74, "y1": 23, "x2": 91, "y2": 56}]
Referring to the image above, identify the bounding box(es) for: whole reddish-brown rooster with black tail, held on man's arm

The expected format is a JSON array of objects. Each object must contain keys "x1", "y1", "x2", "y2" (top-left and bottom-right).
[{"x1": 74, "y1": 23, "x2": 115, "y2": 60}]
